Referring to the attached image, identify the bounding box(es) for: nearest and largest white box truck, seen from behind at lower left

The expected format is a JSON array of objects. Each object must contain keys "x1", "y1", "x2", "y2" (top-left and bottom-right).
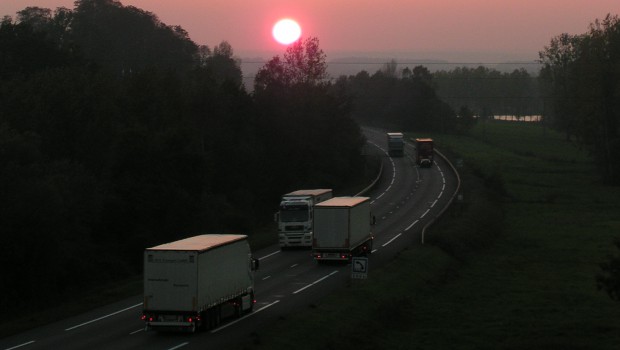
[{"x1": 142, "y1": 235, "x2": 258, "y2": 332}]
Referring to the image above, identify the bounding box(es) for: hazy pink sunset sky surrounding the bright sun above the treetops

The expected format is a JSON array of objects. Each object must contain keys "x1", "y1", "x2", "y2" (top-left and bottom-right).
[{"x1": 0, "y1": 0, "x2": 620, "y2": 60}]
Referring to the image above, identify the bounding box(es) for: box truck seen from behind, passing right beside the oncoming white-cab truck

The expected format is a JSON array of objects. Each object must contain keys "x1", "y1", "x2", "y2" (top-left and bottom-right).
[{"x1": 312, "y1": 197, "x2": 373, "y2": 262}]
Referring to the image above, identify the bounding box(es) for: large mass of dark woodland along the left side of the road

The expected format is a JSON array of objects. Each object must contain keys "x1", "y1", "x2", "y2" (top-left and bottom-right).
[{"x1": 0, "y1": 0, "x2": 365, "y2": 315}]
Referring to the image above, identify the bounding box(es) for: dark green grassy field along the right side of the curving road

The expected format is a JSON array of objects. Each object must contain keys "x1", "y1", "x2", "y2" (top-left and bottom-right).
[{"x1": 239, "y1": 122, "x2": 620, "y2": 349}]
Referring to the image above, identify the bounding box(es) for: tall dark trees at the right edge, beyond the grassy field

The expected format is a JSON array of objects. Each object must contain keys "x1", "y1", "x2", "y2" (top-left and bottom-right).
[{"x1": 539, "y1": 15, "x2": 620, "y2": 185}]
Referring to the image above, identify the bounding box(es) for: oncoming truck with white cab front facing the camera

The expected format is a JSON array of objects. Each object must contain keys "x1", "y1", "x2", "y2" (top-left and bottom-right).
[{"x1": 276, "y1": 189, "x2": 333, "y2": 249}]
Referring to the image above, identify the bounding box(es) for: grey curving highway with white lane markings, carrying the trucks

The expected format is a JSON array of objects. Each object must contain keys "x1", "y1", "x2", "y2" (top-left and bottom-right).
[{"x1": 0, "y1": 129, "x2": 458, "y2": 350}]
